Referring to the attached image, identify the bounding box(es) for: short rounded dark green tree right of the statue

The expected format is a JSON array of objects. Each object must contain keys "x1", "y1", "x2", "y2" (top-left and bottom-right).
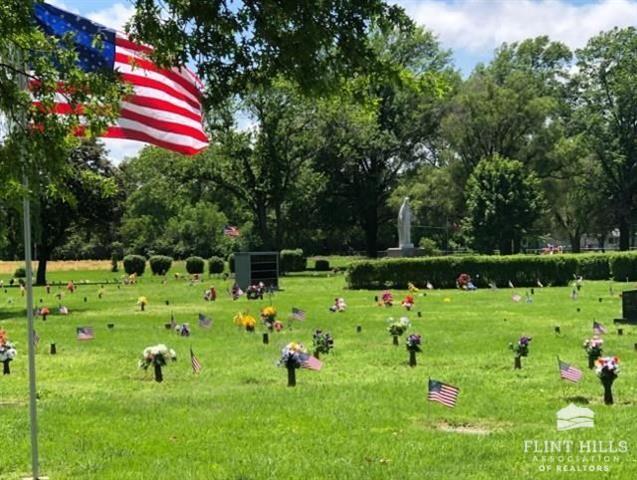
[{"x1": 465, "y1": 155, "x2": 544, "y2": 255}]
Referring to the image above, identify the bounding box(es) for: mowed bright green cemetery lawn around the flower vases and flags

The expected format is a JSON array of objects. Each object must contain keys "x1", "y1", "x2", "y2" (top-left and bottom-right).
[{"x1": 0, "y1": 272, "x2": 637, "y2": 480}]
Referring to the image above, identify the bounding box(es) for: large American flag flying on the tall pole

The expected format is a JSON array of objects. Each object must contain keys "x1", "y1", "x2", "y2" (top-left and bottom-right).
[{"x1": 35, "y1": 3, "x2": 208, "y2": 155}]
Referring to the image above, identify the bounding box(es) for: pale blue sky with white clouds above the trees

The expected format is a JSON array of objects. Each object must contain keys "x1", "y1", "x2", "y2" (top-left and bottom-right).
[{"x1": 49, "y1": 0, "x2": 637, "y2": 162}]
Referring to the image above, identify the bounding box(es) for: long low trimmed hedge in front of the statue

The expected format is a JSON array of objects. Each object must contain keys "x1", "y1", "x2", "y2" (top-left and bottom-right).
[{"x1": 347, "y1": 252, "x2": 637, "y2": 289}]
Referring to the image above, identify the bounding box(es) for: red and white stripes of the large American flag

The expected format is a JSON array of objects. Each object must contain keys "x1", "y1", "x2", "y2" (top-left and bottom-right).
[{"x1": 103, "y1": 32, "x2": 208, "y2": 155}]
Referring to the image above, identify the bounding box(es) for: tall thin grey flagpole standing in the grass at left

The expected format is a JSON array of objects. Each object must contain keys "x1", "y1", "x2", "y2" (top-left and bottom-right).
[{"x1": 22, "y1": 173, "x2": 40, "y2": 480}]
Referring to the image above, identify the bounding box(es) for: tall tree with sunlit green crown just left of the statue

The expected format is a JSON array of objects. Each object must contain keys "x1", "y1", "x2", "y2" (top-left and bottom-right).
[{"x1": 314, "y1": 28, "x2": 457, "y2": 257}]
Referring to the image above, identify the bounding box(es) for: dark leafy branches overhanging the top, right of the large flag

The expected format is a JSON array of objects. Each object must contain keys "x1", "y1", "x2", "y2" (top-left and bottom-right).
[{"x1": 129, "y1": 0, "x2": 412, "y2": 105}]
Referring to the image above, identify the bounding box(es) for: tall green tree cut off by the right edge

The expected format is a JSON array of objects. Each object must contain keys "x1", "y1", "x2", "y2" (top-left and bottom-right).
[{"x1": 575, "y1": 27, "x2": 637, "y2": 250}]
